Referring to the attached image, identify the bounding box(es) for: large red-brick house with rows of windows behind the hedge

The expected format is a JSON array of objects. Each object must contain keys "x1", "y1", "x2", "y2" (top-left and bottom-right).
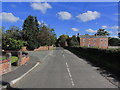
[{"x1": 79, "y1": 34, "x2": 108, "y2": 48}]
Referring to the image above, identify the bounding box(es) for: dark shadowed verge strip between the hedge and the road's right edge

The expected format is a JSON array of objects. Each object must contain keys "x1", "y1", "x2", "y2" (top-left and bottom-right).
[{"x1": 64, "y1": 47, "x2": 120, "y2": 88}]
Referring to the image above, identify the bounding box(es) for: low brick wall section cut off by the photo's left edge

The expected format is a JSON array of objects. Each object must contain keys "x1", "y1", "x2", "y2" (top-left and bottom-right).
[{"x1": 0, "y1": 59, "x2": 11, "y2": 75}]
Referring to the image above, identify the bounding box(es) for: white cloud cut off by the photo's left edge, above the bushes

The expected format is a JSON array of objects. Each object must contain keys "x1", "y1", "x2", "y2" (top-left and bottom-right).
[{"x1": 0, "y1": 12, "x2": 20, "y2": 22}]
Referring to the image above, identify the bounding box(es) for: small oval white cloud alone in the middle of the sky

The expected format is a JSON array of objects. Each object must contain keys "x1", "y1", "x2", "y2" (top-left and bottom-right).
[{"x1": 57, "y1": 11, "x2": 72, "y2": 20}]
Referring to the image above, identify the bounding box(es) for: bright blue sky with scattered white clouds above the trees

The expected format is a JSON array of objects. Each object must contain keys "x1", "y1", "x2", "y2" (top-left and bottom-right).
[{"x1": 0, "y1": 2, "x2": 119, "y2": 37}]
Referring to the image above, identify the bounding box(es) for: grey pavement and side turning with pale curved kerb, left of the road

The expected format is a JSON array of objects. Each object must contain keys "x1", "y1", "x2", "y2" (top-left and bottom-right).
[{"x1": 0, "y1": 51, "x2": 50, "y2": 90}]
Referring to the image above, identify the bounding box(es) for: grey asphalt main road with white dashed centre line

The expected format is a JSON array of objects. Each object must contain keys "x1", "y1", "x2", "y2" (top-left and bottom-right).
[{"x1": 14, "y1": 49, "x2": 116, "y2": 88}]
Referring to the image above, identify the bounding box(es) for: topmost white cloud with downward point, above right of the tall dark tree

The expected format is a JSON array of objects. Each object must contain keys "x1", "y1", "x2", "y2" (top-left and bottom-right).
[{"x1": 31, "y1": 3, "x2": 52, "y2": 14}]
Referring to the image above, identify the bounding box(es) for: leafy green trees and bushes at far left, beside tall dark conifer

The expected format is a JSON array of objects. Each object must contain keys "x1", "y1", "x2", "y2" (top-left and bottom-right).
[{"x1": 2, "y1": 26, "x2": 27, "y2": 50}]
